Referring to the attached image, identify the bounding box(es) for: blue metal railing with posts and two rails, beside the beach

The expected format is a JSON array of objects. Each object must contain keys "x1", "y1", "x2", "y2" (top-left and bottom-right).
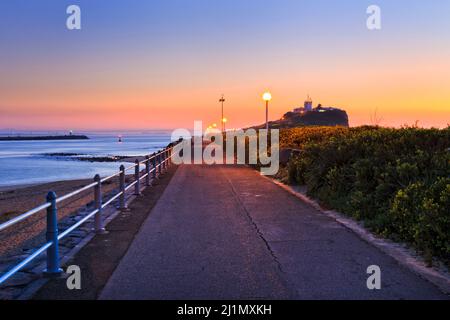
[{"x1": 0, "y1": 145, "x2": 178, "y2": 285}]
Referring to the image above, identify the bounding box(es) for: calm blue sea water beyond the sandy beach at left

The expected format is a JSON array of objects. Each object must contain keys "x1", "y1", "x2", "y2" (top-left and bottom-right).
[{"x1": 0, "y1": 132, "x2": 170, "y2": 187}]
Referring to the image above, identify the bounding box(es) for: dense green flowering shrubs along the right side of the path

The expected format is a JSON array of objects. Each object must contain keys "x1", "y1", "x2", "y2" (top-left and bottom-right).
[{"x1": 280, "y1": 127, "x2": 450, "y2": 266}]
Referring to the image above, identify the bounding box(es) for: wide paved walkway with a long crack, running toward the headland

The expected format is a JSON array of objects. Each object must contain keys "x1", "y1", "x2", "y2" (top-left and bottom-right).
[{"x1": 100, "y1": 165, "x2": 448, "y2": 299}]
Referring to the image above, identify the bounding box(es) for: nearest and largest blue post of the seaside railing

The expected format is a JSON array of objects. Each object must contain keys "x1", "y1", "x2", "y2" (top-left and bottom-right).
[{"x1": 44, "y1": 192, "x2": 62, "y2": 277}]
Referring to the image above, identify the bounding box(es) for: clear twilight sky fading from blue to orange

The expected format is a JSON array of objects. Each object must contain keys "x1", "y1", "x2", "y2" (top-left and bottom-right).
[{"x1": 0, "y1": 0, "x2": 450, "y2": 130}]
